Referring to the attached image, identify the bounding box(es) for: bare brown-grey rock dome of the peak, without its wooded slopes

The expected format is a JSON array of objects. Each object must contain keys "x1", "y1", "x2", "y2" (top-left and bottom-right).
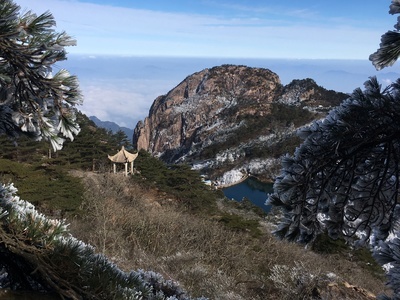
[{"x1": 134, "y1": 65, "x2": 283, "y2": 161}]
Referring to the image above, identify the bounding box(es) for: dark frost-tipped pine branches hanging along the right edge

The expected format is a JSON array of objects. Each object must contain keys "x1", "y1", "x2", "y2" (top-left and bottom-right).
[{"x1": 269, "y1": 0, "x2": 400, "y2": 299}]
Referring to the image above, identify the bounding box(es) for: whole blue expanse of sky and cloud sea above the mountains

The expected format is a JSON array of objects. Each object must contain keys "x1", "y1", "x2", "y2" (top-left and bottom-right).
[{"x1": 14, "y1": 0, "x2": 400, "y2": 128}]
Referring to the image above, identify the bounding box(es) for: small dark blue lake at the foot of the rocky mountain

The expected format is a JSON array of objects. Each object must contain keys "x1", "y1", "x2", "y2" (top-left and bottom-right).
[{"x1": 222, "y1": 177, "x2": 273, "y2": 213}]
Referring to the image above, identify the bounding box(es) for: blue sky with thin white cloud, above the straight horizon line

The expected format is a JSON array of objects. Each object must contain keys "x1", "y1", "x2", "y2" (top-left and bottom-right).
[{"x1": 16, "y1": 0, "x2": 396, "y2": 59}]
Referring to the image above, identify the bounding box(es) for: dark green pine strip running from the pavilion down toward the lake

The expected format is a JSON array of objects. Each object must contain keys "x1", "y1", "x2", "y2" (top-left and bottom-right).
[{"x1": 133, "y1": 150, "x2": 220, "y2": 213}]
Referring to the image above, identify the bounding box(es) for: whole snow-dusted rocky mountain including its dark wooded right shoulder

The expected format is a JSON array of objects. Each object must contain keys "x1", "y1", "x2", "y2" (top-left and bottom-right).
[{"x1": 133, "y1": 65, "x2": 346, "y2": 179}]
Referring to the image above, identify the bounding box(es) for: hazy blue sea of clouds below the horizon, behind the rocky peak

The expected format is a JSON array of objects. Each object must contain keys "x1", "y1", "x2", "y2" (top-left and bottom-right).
[{"x1": 54, "y1": 54, "x2": 400, "y2": 128}]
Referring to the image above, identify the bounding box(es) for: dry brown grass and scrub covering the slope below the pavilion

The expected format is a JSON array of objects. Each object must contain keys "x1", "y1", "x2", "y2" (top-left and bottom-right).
[{"x1": 71, "y1": 174, "x2": 385, "y2": 300}]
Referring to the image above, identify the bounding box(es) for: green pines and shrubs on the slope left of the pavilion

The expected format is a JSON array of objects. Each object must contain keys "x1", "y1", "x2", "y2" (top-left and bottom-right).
[{"x1": 0, "y1": 113, "x2": 130, "y2": 215}]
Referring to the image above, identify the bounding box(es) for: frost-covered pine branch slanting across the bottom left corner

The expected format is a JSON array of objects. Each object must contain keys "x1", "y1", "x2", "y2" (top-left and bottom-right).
[{"x1": 0, "y1": 184, "x2": 205, "y2": 300}]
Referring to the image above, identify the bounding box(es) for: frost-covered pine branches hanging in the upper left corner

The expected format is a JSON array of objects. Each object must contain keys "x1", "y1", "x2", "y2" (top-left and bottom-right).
[{"x1": 0, "y1": 0, "x2": 81, "y2": 150}]
